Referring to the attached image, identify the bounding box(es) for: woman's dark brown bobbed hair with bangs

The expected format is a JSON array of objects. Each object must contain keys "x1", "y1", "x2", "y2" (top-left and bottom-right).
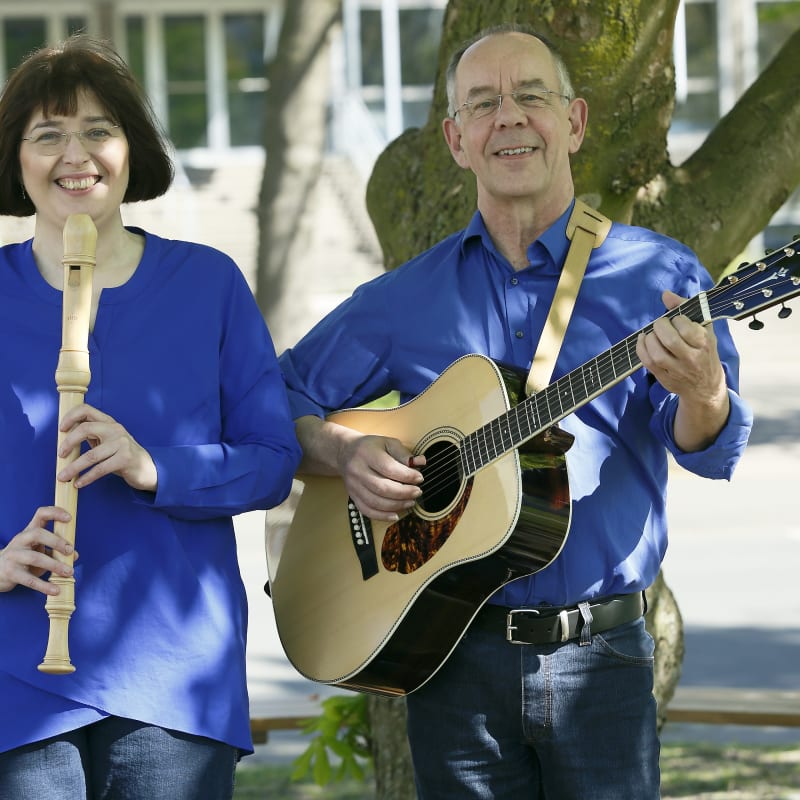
[{"x1": 0, "y1": 34, "x2": 175, "y2": 217}]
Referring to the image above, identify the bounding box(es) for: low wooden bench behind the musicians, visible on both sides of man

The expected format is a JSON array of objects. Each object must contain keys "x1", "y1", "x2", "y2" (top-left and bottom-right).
[{"x1": 250, "y1": 686, "x2": 800, "y2": 744}]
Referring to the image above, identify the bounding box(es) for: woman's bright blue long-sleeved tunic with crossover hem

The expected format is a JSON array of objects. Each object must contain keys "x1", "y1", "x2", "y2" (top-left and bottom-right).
[{"x1": 0, "y1": 230, "x2": 300, "y2": 752}]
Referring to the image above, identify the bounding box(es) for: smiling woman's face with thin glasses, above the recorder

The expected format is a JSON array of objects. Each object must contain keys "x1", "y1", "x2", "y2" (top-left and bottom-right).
[{"x1": 19, "y1": 91, "x2": 130, "y2": 230}]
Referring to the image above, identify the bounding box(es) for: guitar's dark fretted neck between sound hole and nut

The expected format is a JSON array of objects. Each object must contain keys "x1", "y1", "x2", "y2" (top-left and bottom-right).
[{"x1": 460, "y1": 292, "x2": 711, "y2": 476}]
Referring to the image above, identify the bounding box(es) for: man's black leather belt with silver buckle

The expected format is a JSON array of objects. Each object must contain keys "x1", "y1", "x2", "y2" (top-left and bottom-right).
[{"x1": 472, "y1": 592, "x2": 645, "y2": 644}]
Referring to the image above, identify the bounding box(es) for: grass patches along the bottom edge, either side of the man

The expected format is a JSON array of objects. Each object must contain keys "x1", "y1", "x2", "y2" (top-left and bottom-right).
[{"x1": 234, "y1": 743, "x2": 800, "y2": 800}]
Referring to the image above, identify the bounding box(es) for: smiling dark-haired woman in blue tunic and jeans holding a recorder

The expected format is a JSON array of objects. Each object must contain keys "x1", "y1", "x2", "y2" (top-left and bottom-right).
[{"x1": 0, "y1": 36, "x2": 300, "y2": 800}]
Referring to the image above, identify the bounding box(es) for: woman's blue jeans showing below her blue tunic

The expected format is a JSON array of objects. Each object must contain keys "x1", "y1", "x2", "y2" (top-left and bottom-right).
[{"x1": 0, "y1": 717, "x2": 238, "y2": 800}]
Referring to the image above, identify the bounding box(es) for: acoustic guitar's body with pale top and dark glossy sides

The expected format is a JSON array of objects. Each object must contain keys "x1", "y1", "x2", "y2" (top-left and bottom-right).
[{"x1": 267, "y1": 355, "x2": 572, "y2": 695}]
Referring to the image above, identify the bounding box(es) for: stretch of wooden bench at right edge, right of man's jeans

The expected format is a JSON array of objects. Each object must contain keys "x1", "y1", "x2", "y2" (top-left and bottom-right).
[{"x1": 667, "y1": 686, "x2": 800, "y2": 728}]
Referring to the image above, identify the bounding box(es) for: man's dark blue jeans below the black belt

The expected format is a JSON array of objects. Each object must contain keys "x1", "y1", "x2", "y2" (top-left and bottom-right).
[{"x1": 407, "y1": 618, "x2": 660, "y2": 800}]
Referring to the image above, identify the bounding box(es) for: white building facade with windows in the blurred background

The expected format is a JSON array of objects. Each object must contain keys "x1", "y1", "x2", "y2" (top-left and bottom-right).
[{"x1": 0, "y1": 0, "x2": 800, "y2": 243}]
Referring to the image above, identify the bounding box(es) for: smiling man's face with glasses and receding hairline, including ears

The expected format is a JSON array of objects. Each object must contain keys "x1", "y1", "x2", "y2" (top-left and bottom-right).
[{"x1": 443, "y1": 33, "x2": 586, "y2": 210}]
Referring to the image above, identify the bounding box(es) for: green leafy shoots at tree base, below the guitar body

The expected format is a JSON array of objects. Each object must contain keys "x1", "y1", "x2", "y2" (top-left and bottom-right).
[{"x1": 292, "y1": 694, "x2": 371, "y2": 786}]
